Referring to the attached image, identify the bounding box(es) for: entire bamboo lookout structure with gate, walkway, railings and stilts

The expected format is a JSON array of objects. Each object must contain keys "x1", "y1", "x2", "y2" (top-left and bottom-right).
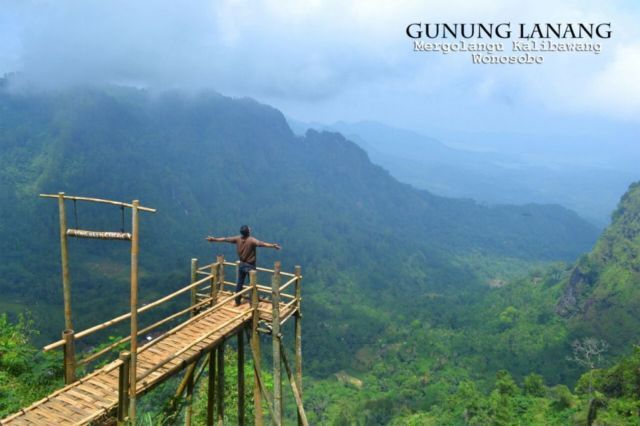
[{"x1": 8, "y1": 193, "x2": 308, "y2": 425}]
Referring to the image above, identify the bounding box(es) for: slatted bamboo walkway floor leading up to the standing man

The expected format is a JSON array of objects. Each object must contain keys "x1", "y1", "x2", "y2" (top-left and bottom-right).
[{"x1": 0, "y1": 292, "x2": 296, "y2": 425}]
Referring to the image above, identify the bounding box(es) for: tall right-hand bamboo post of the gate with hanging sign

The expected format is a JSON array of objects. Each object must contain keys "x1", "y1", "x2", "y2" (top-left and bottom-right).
[{"x1": 129, "y1": 200, "x2": 140, "y2": 424}]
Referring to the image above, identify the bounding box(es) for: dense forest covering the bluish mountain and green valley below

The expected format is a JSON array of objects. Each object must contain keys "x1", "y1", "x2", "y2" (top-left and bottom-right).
[{"x1": 0, "y1": 87, "x2": 640, "y2": 424}]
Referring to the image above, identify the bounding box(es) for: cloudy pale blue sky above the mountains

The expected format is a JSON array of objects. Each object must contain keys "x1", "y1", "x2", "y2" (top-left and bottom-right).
[{"x1": 0, "y1": 0, "x2": 640, "y2": 161}]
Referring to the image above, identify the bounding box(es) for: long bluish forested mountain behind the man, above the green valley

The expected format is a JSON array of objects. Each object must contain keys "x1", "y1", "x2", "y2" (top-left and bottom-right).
[{"x1": 0, "y1": 88, "x2": 596, "y2": 340}]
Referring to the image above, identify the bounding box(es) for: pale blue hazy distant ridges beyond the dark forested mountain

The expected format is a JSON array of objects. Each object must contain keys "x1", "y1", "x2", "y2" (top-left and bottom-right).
[{"x1": 289, "y1": 119, "x2": 640, "y2": 228}]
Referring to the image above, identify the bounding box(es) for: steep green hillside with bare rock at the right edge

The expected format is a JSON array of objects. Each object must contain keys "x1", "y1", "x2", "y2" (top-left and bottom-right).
[{"x1": 557, "y1": 182, "x2": 640, "y2": 348}]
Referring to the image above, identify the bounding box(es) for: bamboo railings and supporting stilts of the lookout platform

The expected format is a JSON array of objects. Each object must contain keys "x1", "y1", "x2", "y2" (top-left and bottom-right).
[{"x1": 37, "y1": 256, "x2": 308, "y2": 425}]
